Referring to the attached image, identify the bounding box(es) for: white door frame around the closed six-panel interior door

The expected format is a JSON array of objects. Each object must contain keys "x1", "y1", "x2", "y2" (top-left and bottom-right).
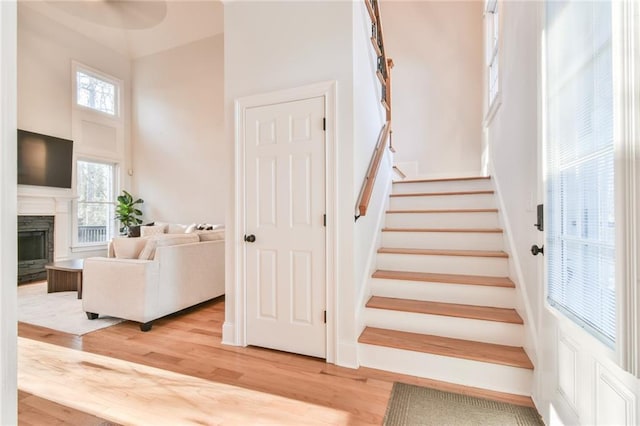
[{"x1": 231, "y1": 81, "x2": 338, "y2": 363}]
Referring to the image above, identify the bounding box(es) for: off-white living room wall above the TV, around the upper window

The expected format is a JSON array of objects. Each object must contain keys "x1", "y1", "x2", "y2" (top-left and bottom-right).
[{"x1": 18, "y1": 2, "x2": 131, "y2": 156}]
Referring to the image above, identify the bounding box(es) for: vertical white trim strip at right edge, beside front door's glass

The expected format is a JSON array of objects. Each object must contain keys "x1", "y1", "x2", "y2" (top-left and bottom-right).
[{"x1": 612, "y1": 1, "x2": 640, "y2": 377}]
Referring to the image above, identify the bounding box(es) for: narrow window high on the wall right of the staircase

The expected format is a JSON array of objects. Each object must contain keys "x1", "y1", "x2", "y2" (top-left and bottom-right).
[{"x1": 484, "y1": 0, "x2": 500, "y2": 111}]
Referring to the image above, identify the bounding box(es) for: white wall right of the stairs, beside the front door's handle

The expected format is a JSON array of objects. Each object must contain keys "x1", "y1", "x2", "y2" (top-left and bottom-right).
[{"x1": 488, "y1": 2, "x2": 544, "y2": 357}]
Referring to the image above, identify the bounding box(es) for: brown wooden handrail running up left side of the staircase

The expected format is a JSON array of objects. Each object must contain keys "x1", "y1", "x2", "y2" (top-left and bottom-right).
[{"x1": 356, "y1": 0, "x2": 395, "y2": 220}]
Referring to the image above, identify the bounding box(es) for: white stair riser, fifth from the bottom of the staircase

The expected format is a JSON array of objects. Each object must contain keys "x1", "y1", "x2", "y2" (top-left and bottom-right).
[{"x1": 382, "y1": 231, "x2": 504, "y2": 250}]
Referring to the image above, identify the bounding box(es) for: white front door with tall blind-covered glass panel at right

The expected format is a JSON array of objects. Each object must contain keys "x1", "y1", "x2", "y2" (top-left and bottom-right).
[{"x1": 536, "y1": 0, "x2": 638, "y2": 425}]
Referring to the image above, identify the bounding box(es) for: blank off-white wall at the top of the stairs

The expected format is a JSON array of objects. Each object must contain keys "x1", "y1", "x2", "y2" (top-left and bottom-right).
[{"x1": 381, "y1": 1, "x2": 484, "y2": 176}]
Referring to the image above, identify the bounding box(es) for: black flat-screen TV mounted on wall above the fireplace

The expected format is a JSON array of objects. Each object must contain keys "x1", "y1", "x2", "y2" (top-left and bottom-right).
[{"x1": 18, "y1": 129, "x2": 73, "y2": 188}]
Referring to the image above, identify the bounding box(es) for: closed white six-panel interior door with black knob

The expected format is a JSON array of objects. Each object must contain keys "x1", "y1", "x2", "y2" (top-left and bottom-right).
[{"x1": 244, "y1": 97, "x2": 326, "y2": 358}]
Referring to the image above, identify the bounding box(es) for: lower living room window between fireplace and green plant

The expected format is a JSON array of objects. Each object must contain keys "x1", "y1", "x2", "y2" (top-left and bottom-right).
[{"x1": 76, "y1": 160, "x2": 116, "y2": 245}]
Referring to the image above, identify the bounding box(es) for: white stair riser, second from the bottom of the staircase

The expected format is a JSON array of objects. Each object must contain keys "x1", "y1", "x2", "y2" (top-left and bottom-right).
[{"x1": 364, "y1": 308, "x2": 524, "y2": 346}]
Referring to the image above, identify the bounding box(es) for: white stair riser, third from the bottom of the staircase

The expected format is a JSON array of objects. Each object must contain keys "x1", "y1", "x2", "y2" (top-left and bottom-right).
[{"x1": 371, "y1": 278, "x2": 516, "y2": 308}]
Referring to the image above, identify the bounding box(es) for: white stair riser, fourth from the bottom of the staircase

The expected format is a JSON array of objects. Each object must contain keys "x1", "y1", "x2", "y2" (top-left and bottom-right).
[{"x1": 377, "y1": 253, "x2": 509, "y2": 277}]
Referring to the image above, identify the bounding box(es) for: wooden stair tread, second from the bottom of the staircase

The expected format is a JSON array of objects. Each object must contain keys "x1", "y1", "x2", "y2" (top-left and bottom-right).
[{"x1": 366, "y1": 296, "x2": 524, "y2": 324}]
